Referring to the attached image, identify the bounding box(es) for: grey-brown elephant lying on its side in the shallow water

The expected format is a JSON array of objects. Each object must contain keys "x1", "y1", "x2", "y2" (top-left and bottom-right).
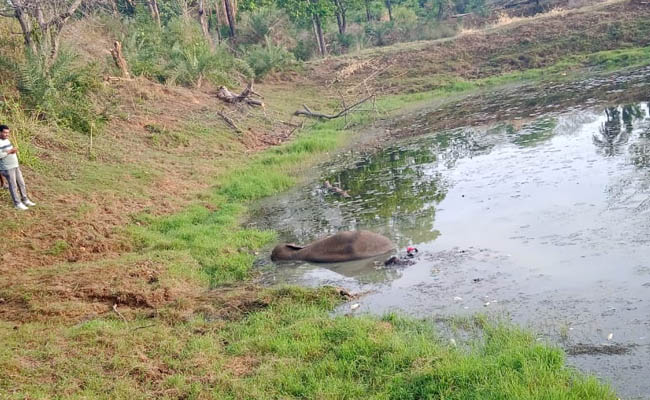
[{"x1": 271, "y1": 231, "x2": 395, "y2": 263}]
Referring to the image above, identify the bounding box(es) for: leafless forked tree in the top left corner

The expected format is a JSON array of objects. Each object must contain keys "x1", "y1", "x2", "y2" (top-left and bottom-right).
[{"x1": 0, "y1": 0, "x2": 88, "y2": 65}]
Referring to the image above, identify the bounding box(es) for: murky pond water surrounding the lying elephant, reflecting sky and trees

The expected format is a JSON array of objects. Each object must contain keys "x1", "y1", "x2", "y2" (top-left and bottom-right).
[{"x1": 251, "y1": 95, "x2": 650, "y2": 398}]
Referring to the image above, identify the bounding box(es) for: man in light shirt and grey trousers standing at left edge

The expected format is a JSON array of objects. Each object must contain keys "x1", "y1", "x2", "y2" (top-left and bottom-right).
[{"x1": 0, "y1": 125, "x2": 36, "y2": 210}]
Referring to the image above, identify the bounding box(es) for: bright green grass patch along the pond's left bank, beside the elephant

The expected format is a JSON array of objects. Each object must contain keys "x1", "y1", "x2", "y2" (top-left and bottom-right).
[{"x1": 130, "y1": 121, "x2": 346, "y2": 286}]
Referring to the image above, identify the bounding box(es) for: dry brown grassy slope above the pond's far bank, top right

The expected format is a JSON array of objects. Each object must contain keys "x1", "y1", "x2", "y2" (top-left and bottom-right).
[{"x1": 310, "y1": 0, "x2": 650, "y2": 93}]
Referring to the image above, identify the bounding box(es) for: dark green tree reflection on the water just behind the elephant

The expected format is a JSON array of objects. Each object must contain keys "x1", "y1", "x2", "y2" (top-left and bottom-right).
[{"x1": 324, "y1": 141, "x2": 445, "y2": 245}]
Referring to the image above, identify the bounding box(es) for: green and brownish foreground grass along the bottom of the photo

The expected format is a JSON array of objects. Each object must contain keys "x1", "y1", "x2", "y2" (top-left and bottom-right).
[{"x1": 0, "y1": 288, "x2": 615, "y2": 400}]
